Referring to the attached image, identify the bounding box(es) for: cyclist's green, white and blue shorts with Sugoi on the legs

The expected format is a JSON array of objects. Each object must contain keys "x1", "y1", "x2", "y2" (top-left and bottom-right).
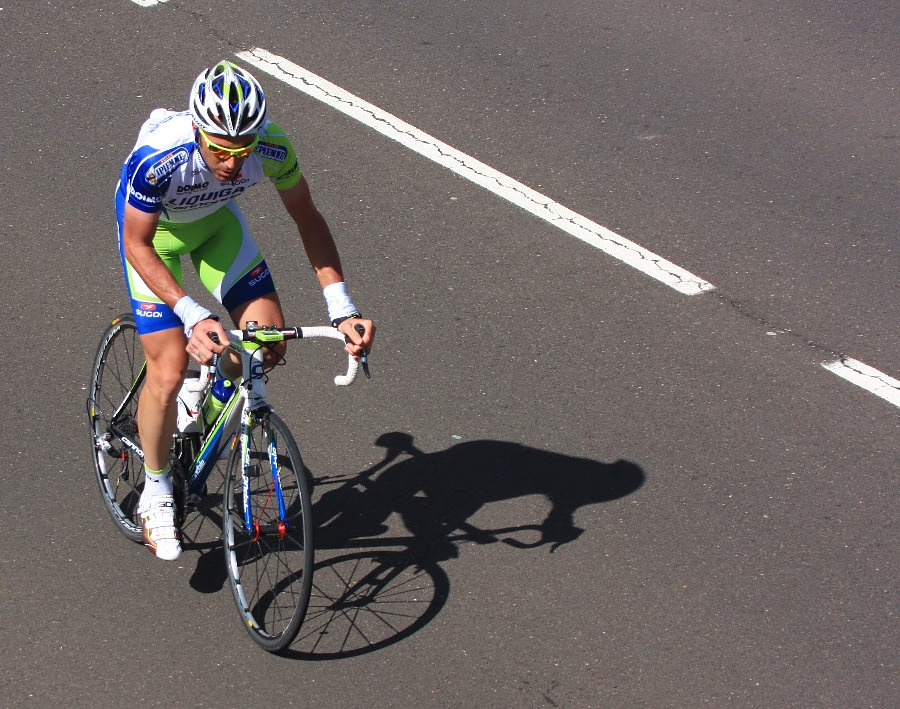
[{"x1": 116, "y1": 193, "x2": 275, "y2": 335}]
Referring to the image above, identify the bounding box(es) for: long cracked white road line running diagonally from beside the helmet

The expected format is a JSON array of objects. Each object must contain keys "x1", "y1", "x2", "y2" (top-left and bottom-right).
[{"x1": 237, "y1": 48, "x2": 714, "y2": 295}]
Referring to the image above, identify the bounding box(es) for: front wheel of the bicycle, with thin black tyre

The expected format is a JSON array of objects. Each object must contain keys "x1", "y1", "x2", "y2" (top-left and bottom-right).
[{"x1": 222, "y1": 412, "x2": 314, "y2": 652}]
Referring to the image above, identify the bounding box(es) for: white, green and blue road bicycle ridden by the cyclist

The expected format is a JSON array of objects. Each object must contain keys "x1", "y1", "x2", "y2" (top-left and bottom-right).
[{"x1": 87, "y1": 314, "x2": 359, "y2": 652}]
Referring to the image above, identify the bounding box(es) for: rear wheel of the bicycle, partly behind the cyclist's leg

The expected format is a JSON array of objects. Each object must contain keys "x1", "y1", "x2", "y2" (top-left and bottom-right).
[{"x1": 87, "y1": 314, "x2": 144, "y2": 542}]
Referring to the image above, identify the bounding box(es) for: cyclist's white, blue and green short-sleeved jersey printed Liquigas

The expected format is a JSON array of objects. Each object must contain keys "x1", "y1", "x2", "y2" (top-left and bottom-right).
[{"x1": 118, "y1": 108, "x2": 300, "y2": 223}]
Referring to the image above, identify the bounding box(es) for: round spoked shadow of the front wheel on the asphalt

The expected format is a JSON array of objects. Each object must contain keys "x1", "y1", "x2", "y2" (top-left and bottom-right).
[{"x1": 284, "y1": 551, "x2": 450, "y2": 660}]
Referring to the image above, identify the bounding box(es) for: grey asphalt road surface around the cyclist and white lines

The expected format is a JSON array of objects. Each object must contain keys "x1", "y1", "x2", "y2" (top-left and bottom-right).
[{"x1": 0, "y1": 0, "x2": 900, "y2": 707}]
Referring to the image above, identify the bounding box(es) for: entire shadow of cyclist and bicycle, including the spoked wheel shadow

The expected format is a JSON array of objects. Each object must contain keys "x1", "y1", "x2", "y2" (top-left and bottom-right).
[{"x1": 284, "y1": 432, "x2": 644, "y2": 660}]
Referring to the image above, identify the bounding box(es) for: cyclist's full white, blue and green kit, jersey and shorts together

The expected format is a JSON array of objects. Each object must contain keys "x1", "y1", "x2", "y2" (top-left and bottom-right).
[{"x1": 116, "y1": 109, "x2": 301, "y2": 334}]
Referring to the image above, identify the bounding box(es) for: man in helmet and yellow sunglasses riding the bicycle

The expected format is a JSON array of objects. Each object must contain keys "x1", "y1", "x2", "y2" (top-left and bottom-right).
[{"x1": 116, "y1": 61, "x2": 375, "y2": 560}]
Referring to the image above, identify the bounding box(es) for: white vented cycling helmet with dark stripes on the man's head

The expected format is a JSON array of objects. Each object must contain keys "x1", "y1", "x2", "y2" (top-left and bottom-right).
[{"x1": 188, "y1": 61, "x2": 266, "y2": 138}]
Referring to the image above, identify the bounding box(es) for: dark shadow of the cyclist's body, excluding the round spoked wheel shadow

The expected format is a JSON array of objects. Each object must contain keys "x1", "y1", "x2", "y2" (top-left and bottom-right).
[{"x1": 314, "y1": 433, "x2": 644, "y2": 562}]
